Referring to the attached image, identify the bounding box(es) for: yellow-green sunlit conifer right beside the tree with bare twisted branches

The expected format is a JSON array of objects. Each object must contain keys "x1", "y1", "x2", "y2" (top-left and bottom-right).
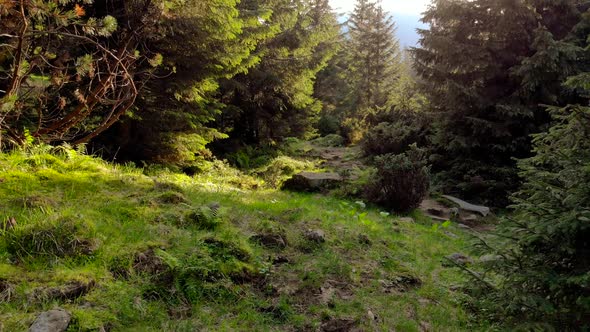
[{"x1": 95, "y1": 0, "x2": 276, "y2": 166}]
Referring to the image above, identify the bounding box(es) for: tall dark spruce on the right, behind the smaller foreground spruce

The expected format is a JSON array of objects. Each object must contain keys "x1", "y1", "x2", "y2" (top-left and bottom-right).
[{"x1": 412, "y1": 0, "x2": 580, "y2": 205}]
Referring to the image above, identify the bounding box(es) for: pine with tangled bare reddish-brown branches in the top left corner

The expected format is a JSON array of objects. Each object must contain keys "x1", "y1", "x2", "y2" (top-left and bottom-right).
[{"x1": 0, "y1": 0, "x2": 167, "y2": 147}]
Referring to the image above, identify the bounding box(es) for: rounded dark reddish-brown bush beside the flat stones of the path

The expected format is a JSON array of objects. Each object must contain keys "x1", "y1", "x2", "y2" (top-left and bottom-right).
[{"x1": 365, "y1": 145, "x2": 429, "y2": 212}]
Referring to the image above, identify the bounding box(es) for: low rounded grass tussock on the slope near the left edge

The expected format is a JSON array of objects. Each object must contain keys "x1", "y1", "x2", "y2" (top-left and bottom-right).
[{"x1": 5, "y1": 218, "x2": 97, "y2": 259}]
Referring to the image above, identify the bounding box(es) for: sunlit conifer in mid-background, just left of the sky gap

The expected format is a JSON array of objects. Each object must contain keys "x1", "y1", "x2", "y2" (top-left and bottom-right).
[{"x1": 219, "y1": 0, "x2": 338, "y2": 145}]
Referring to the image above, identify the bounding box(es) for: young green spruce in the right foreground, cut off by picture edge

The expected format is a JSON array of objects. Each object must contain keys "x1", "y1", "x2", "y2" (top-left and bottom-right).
[{"x1": 478, "y1": 105, "x2": 590, "y2": 330}]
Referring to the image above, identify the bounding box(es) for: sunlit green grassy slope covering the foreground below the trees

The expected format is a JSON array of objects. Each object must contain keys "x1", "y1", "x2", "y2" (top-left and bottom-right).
[{"x1": 0, "y1": 149, "x2": 483, "y2": 331}]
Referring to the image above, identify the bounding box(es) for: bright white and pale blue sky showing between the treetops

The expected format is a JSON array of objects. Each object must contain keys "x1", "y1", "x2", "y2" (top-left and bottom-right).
[{"x1": 330, "y1": 0, "x2": 430, "y2": 47}]
